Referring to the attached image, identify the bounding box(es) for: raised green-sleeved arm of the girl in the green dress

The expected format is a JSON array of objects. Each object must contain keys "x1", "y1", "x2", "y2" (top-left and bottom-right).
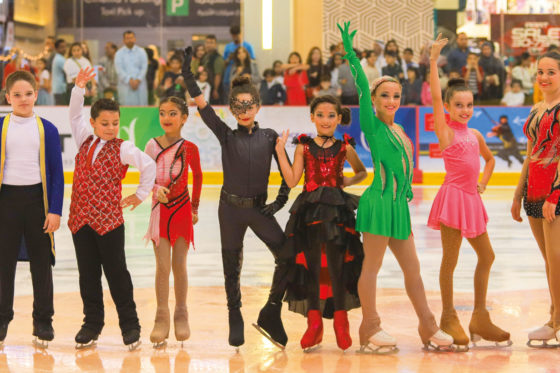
[{"x1": 337, "y1": 22, "x2": 381, "y2": 132}]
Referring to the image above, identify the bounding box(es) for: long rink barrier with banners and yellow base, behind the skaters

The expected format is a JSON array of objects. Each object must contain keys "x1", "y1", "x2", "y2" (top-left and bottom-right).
[{"x1": 0, "y1": 106, "x2": 530, "y2": 185}]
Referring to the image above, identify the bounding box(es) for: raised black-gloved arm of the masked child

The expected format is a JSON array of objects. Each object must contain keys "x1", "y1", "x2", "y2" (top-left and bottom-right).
[{"x1": 181, "y1": 47, "x2": 231, "y2": 144}]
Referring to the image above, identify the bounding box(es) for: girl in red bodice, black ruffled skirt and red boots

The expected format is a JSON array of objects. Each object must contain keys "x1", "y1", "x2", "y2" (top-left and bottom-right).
[{"x1": 276, "y1": 95, "x2": 367, "y2": 350}]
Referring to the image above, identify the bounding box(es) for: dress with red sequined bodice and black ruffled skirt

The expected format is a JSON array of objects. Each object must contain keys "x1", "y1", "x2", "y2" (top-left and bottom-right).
[{"x1": 282, "y1": 135, "x2": 364, "y2": 318}]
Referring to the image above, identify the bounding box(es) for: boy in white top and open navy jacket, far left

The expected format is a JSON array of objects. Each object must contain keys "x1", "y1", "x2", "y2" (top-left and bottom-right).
[{"x1": 0, "y1": 71, "x2": 64, "y2": 348}]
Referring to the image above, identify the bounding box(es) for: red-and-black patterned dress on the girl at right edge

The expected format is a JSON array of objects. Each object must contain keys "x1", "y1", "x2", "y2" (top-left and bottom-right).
[{"x1": 523, "y1": 103, "x2": 560, "y2": 218}]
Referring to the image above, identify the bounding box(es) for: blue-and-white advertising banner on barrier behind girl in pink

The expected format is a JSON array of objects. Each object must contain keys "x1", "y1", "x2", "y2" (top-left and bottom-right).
[{"x1": 418, "y1": 106, "x2": 531, "y2": 172}]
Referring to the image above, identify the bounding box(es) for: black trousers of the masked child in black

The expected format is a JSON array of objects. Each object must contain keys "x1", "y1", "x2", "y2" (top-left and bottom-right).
[{"x1": 218, "y1": 201, "x2": 289, "y2": 309}]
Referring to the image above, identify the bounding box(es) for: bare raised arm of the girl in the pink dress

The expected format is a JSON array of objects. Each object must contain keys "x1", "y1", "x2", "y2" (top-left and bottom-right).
[{"x1": 430, "y1": 34, "x2": 454, "y2": 150}]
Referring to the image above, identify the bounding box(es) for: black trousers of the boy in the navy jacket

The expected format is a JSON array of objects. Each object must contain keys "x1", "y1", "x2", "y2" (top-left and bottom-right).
[{"x1": 0, "y1": 184, "x2": 54, "y2": 324}]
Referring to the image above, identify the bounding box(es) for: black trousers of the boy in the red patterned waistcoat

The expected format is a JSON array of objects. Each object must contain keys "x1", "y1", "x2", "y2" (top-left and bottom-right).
[{"x1": 72, "y1": 225, "x2": 140, "y2": 333}]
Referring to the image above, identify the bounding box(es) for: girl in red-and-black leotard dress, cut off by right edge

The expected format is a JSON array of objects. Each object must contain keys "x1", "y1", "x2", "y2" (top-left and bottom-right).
[{"x1": 511, "y1": 52, "x2": 560, "y2": 347}]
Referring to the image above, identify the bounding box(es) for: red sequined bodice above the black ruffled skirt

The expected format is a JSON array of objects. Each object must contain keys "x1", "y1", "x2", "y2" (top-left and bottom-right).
[{"x1": 301, "y1": 138, "x2": 346, "y2": 192}]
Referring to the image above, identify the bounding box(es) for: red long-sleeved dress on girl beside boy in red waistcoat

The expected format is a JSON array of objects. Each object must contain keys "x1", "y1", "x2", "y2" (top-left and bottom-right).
[{"x1": 145, "y1": 138, "x2": 202, "y2": 246}]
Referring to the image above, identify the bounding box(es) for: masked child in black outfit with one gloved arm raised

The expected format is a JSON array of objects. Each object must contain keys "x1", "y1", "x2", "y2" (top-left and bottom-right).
[{"x1": 183, "y1": 47, "x2": 290, "y2": 348}]
